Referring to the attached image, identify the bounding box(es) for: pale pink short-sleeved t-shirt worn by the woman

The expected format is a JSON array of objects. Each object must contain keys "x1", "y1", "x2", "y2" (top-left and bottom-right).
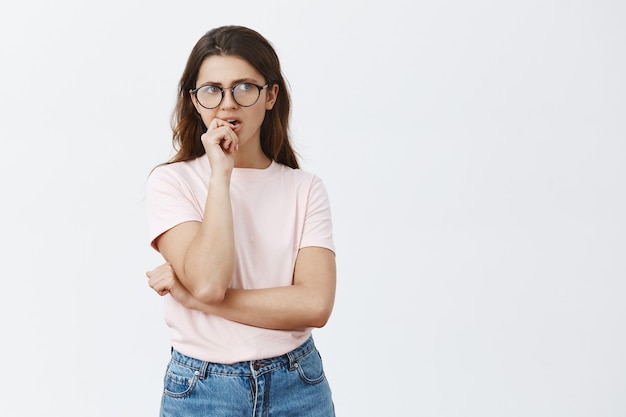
[{"x1": 146, "y1": 156, "x2": 335, "y2": 363}]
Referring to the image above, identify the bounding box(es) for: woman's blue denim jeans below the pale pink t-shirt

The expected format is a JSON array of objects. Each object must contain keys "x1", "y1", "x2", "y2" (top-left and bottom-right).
[{"x1": 161, "y1": 338, "x2": 335, "y2": 417}]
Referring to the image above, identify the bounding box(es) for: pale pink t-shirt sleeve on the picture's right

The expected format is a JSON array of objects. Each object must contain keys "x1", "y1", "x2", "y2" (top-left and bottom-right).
[{"x1": 300, "y1": 177, "x2": 335, "y2": 252}]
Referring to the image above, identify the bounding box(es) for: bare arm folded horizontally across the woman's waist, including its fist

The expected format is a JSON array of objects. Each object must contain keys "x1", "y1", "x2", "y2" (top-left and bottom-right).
[{"x1": 148, "y1": 247, "x2": 336, "y2": 330}]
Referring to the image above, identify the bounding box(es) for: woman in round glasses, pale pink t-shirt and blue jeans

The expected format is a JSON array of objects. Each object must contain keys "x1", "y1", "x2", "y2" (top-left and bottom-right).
[{"x1": 146, "y1": 26, "x2": 336, "y2": 417}]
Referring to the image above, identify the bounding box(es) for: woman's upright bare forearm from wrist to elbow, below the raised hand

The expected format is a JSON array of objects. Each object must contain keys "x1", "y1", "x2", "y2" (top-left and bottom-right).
[{"x1": 180, "y1": 177, "x2": 235, "y2": 304}]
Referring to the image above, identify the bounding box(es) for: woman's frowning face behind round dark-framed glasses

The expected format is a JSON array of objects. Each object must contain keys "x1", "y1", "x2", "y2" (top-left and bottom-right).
[{"x1": 191, "y1": 55, "x2": 278, "y2": 149}]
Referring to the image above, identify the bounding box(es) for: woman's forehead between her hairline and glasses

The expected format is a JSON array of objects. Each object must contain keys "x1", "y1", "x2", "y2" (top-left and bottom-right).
[{"x1": 197, "y1": 55, "x2": 263, "y2": 85}]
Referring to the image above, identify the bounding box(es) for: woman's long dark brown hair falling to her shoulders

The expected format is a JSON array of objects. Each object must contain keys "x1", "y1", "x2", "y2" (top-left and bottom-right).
[{"x1": 167, "y1": 26, "x2": 299, "y2": 168}]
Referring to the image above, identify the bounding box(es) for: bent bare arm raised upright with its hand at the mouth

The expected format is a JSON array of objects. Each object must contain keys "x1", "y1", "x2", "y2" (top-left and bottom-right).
[{"x1": 156, "y1": 119, "x2": 237, "y2": 304}]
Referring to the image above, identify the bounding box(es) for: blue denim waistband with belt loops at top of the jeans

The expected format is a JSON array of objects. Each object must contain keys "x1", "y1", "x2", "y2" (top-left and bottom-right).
[{"x1": 172, "y1": 336, "x2": 315, "y2": 379}]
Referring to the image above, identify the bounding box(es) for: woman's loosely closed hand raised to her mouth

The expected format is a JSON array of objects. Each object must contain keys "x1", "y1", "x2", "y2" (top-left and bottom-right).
[{"x1": 201, "y1": 118, "x2": 239, "y2": 175}]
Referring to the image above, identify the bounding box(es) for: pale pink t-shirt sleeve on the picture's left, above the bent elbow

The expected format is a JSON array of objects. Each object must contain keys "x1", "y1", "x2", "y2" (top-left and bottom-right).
[{"x1": 146, "y1": 165, "x2": 202, "y2": 250}]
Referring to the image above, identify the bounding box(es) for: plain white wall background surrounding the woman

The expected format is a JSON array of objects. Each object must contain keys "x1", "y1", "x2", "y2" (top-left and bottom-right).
[{"x1": 0, "y1": 0, "x2": 626, "y2": 417}]
